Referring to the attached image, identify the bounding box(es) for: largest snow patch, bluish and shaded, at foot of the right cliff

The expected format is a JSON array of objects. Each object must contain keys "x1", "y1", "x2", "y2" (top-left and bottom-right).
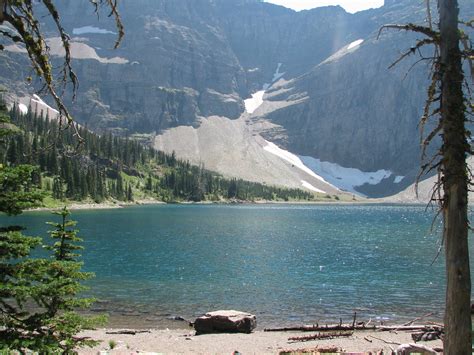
[{"x1": 299, "y1": 156, "x2": 392, "y2": 195}]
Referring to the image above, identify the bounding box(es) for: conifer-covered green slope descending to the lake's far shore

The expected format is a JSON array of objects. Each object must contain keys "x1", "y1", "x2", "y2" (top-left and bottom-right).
[{"x1": 0, "y1": 109, "x2": 313, "y2": 202}]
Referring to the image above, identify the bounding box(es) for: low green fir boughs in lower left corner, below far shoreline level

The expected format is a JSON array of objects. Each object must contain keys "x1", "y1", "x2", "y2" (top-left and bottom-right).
[{"x1": 0, "y1": 208, "x2": 105, "y2": 354}]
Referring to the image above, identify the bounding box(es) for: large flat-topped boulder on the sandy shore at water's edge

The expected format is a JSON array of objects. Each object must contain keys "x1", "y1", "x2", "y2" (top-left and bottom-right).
[{"x1": 194, "y1": 311, "x2": 257, "y2": 334}]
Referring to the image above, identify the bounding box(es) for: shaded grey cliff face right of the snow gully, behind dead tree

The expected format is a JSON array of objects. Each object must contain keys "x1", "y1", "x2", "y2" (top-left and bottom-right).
[{"x1": 258, "y1": 34, "x2": 427, "y2": 174}]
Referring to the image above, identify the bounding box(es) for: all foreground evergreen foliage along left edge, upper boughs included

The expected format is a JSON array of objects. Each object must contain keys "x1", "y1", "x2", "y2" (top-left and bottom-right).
[{"x1": 0, "y1": 97, "x2": 104, "y2": 354}]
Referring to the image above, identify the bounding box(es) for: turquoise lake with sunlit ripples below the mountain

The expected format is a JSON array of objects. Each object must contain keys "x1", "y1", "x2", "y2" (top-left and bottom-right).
[{"x1": 0, "y1": 205, "x2": 472, "y2": 327}]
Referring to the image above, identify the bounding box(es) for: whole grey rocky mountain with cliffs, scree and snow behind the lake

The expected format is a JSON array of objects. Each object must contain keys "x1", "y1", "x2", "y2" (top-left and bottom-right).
[{"x1": 0, "y1": 0, "x2": 474, "y2": 197}]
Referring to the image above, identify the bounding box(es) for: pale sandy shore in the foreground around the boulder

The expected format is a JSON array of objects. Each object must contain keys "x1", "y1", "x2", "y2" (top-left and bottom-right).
[{"x1": 79, "y1": 328, "x2": 443, "y2": 355}]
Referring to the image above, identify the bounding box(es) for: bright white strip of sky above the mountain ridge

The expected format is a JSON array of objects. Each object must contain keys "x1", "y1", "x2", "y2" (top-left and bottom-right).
[{"x1": 265, "y1": 0, "x2": 384, "y2": 13}]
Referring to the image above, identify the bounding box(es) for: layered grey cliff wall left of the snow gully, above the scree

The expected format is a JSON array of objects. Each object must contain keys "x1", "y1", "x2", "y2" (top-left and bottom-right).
[{"x1": 1, "y1": 0, "x2": 376, "y2": 134}]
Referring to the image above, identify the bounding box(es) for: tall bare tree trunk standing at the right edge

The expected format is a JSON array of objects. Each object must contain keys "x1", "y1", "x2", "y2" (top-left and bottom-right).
[{"x1": 438, "y1": 0, "x2": 471, "y2": 355}]
